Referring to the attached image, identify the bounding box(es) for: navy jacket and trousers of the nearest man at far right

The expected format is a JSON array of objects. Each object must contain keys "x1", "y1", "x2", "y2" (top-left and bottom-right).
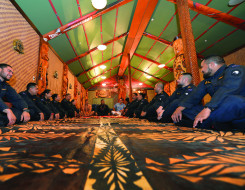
[{"x1": 180, "y1": 64, "x2": 245, "y2": 128}]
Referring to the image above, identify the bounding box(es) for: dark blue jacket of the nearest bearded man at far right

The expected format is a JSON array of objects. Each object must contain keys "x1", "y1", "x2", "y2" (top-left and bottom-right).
[{"x1": 180, "y1": 64, "x2": 245, "y2": 110}]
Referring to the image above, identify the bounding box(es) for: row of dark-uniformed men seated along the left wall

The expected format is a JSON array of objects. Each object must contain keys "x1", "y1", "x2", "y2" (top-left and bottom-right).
[{"x1": 0, "y1": 63, "x2": 88, "y2": 126}]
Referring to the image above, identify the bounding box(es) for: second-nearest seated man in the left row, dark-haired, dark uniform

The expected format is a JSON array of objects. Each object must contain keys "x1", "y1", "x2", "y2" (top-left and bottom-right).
[{"x1": 19, "y1": 83, "x2": 45, "y2": 121}]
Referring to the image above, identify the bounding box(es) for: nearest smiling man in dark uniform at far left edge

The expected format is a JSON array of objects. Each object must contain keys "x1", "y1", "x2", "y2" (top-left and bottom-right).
[{"x1": 0, "y1": 63, "x2": 30, "y2": 126}]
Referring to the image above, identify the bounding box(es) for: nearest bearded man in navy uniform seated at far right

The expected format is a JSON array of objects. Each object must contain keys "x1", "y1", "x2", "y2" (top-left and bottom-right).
[{"x1": 172, "y1": 56, "x2": 245, "y2": 129}]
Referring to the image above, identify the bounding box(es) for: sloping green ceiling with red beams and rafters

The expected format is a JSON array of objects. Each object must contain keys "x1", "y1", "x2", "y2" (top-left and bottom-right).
[{"x1": 11, "y1": 0, "x2": 245, "y2": 89}]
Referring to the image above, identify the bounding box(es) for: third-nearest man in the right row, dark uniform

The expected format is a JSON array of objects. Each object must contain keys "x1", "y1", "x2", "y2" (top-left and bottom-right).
[{"x1": 140, "y1": 82, "x2": 169, "y2": 121}]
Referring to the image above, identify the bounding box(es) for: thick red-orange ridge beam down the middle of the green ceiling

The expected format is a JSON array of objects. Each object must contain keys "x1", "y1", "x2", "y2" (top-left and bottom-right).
[{"x1": 118, "y1": 0, "x2": 158, "y2": 76}]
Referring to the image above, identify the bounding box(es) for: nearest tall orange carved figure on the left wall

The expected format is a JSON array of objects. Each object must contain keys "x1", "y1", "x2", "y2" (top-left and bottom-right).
[{"x1": 37, "y1": 42, "x2": 49, "y2": 94}]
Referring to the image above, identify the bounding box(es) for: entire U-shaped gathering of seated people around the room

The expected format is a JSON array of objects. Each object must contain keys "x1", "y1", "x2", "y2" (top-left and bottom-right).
[{"x1": 0, "y1": 56, "x2": 245, "y2": 128}]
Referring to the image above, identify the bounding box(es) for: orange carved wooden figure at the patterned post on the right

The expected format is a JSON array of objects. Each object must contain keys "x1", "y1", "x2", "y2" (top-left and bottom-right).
[{"x1": 173, "y1": 37, "x2": 186, "y2": 80}]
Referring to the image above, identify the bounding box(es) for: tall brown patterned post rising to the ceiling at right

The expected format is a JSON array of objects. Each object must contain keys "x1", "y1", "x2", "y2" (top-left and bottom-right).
[{"x1": 176, "y1": 0, "x2": 200, "y2": 85}]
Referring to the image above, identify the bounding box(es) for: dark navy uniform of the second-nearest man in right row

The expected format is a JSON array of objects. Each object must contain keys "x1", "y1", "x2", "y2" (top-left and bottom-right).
[{"x1": 161, "y1": 84, "x2": 196, "y2": 123}]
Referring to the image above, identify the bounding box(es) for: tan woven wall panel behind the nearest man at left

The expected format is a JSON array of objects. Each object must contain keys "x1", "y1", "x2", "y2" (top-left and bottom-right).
[{"x1": 0, "y1": 0, "x2": 40, "y2": 92}]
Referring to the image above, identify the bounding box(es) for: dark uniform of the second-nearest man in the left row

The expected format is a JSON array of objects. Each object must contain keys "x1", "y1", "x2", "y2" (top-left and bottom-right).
[{"x1": 19, "y1": 90, "x2": 42, "y2": 121}]
